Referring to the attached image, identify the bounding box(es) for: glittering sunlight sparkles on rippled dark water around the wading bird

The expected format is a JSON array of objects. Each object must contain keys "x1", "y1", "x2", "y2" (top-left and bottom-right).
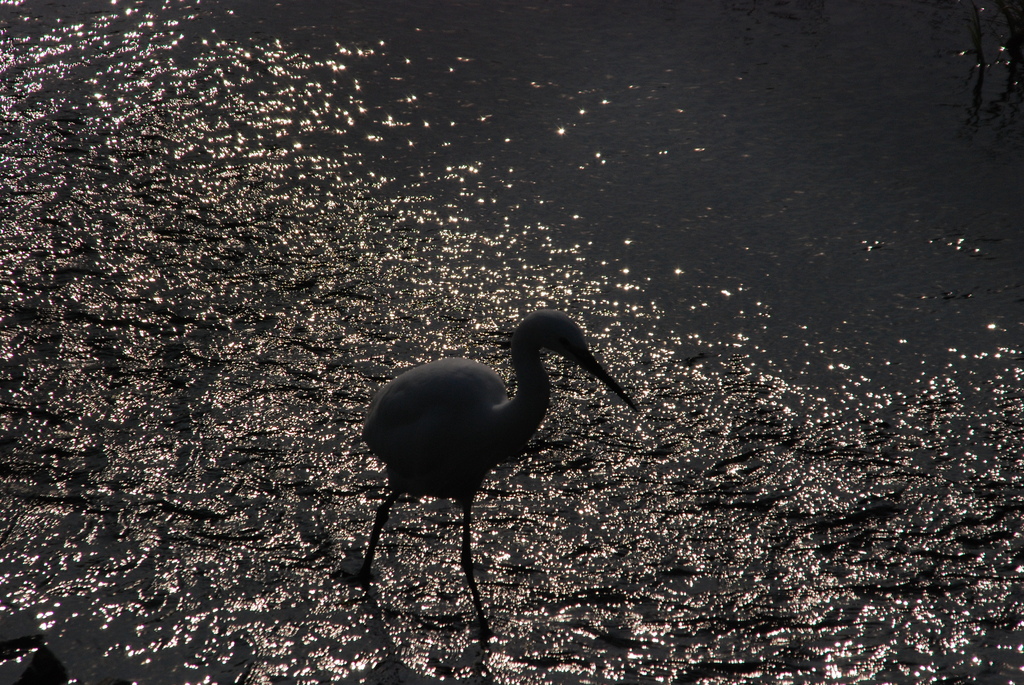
[{"x1": 0, "y1": 2, "x2": 1024, "y2": 683}]
